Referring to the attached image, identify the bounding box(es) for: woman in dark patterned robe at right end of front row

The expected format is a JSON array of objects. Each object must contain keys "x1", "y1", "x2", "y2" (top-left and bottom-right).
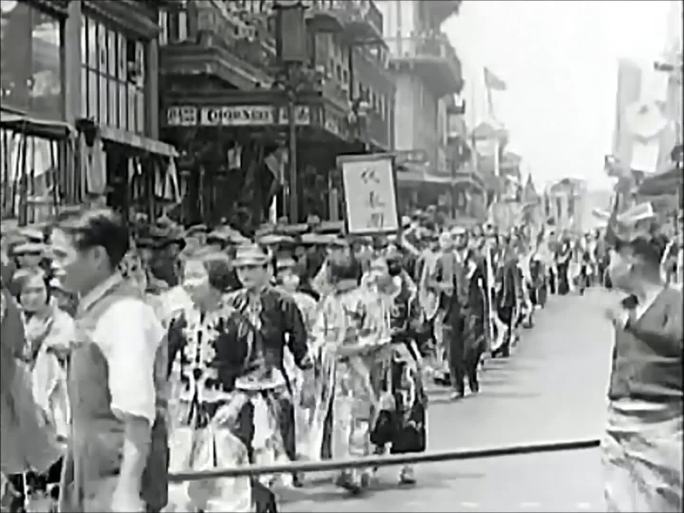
[{"x1": 371, "y1": 252, "x2": 427, "y2": 484}]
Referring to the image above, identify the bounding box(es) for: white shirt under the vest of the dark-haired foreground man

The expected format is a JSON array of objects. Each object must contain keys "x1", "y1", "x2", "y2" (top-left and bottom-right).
[{"x1": 79, "y1": 273, "x2": 164, "y2": 424}]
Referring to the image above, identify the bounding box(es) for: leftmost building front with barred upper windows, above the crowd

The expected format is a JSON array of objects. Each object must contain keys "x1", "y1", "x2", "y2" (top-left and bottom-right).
[{"x1": 1, "y1": 0, "x2": 176, "y2": 222}]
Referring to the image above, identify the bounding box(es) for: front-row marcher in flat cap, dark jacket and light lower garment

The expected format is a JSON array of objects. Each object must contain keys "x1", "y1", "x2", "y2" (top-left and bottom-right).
[{"x1": 228, "y1": 244, "x2": 312, "y2": 485}]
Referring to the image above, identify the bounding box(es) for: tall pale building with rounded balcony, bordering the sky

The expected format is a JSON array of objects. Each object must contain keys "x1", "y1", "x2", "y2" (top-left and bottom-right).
[{"x1": 378, "y1": 0, "x2": 463, "y2": 216}]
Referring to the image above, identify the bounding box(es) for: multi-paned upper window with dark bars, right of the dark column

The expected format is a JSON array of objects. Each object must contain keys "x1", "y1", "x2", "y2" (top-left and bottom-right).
[{"x1": 81, "y1": 17, "x2": 145, "y2": 133}]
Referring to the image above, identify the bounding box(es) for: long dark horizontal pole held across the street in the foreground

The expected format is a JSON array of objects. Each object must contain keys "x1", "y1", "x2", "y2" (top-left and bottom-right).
[{"x1": 169, "y1": 439, "x2": 600, "y2": 483}]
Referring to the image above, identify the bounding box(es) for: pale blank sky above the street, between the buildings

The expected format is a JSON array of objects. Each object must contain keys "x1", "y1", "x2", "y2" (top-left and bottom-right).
[{"x1": 443, "y1": 0, "x2": 669, "y2": 189}]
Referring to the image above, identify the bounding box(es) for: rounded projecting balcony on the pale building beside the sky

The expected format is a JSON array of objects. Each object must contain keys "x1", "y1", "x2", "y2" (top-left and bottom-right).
[{"x1": 386, "y1": 33, "x2": 463, "y2": 96}]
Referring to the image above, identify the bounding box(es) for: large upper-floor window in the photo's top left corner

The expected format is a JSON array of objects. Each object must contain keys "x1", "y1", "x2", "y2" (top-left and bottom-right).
[{"x1": 0, "y1": 2, "x2": 63, "y2": 119}]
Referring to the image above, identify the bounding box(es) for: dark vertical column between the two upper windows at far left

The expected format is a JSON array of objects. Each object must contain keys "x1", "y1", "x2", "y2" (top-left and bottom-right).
[{"x1": 63, "y1": 0, "x2": 83, "y2": 126}]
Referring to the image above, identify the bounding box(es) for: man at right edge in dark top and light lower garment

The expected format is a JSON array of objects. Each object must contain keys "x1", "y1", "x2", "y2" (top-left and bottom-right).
[{"x1": 602, "y1": 229, "x2": 684, "y2": 512}]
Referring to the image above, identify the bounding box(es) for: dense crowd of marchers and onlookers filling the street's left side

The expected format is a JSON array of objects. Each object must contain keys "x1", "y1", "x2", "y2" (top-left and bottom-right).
[{"x1": 0, "y1": 206, "x2": 681, "y2": 512}]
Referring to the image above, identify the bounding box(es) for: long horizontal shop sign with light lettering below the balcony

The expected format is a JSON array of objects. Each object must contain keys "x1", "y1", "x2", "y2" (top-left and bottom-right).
[{"x1": 166, "y1": 105, "x2": 311, "y2": 126}]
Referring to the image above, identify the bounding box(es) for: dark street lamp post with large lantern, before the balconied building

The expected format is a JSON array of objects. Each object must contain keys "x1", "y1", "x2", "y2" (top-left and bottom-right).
[{"x1": 274, "y1": 0, "x2": 307, "y2": 223}]
